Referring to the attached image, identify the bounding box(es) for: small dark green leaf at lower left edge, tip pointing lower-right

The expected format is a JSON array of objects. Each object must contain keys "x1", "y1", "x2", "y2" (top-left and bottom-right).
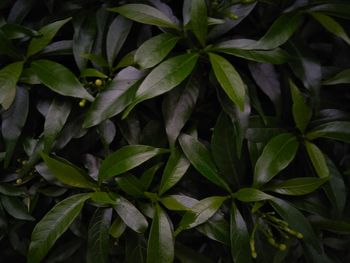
[{"x1": 0, "y1": 195, "x2": 35, "y2": 221}]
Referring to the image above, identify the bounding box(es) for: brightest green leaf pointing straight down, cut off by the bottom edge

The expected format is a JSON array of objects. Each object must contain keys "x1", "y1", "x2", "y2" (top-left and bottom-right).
[{"x1": 146, "y1": 204, "x2": 175, "y2": 263}]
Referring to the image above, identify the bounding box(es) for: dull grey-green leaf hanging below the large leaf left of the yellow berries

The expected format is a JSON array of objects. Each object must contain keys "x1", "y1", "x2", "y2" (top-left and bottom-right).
[{"x1": 44, "y1": 99, "x2": 71, "y2": 153}]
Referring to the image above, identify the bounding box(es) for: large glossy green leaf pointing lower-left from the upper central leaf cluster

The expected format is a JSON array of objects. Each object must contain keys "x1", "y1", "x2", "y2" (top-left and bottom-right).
[{"x1": 123, "y1": 53, "x2": 199, "y2": 118}]
